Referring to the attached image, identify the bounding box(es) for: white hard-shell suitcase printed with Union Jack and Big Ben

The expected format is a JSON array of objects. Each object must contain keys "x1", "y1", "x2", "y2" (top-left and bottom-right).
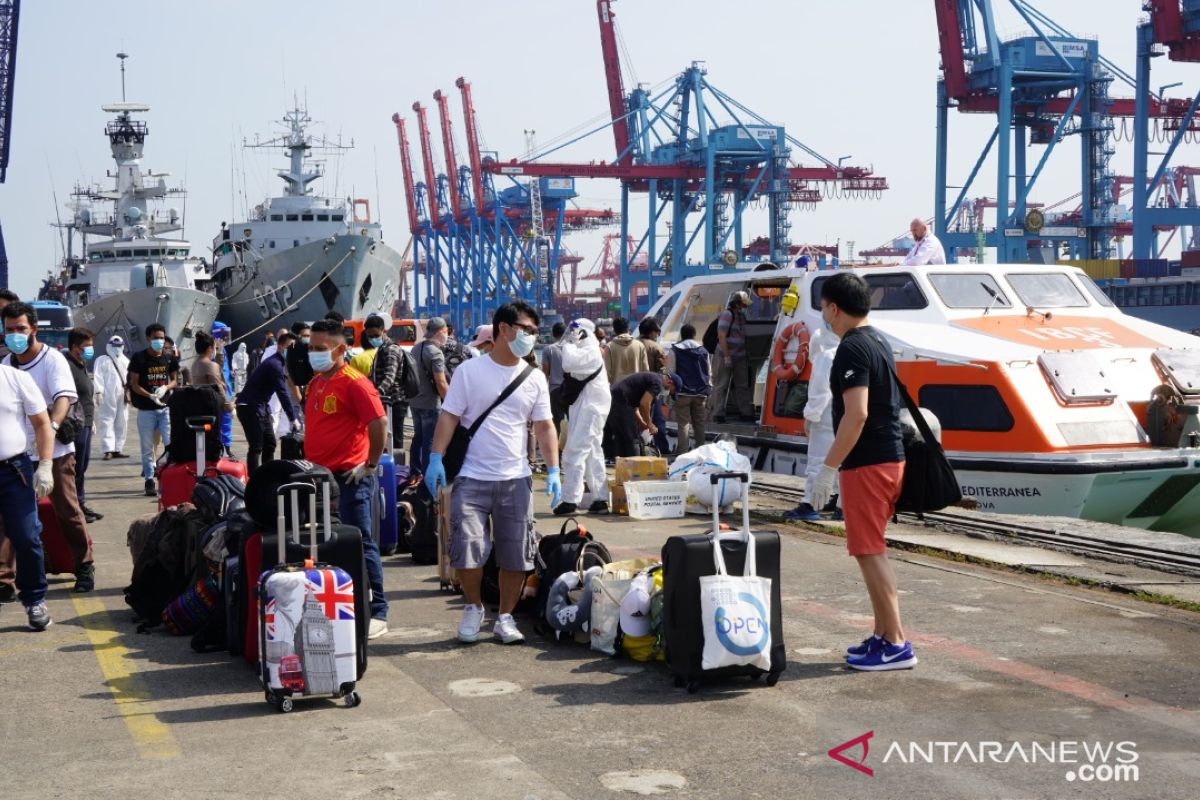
[{"x1": 258, "y1": 482, "x2": 364, "y2": 711}]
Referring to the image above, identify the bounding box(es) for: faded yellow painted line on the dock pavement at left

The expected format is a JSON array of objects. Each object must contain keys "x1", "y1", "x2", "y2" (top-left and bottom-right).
[{"x1": 71, "y1": 596, "x2": 181, "y2": 759}]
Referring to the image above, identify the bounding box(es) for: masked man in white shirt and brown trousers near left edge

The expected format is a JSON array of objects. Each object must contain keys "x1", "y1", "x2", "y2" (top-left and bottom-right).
[{"x1": 0, "y1": 302, "x2": 96, "y2": 593}]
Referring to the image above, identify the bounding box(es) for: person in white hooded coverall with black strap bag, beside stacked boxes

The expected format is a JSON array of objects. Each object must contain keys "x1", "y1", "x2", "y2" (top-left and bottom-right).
[{"x1": 554, "y1": 319, "x2": 612, "y2": 516}]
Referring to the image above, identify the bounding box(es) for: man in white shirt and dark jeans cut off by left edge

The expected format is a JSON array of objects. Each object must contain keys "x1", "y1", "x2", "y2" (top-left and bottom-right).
[{"x1": 0, "y1": 366, "x2": 54, "y2": 631}]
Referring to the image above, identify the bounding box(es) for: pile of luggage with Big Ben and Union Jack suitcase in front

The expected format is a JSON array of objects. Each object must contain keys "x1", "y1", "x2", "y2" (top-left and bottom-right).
[{"x1": 125, "y1": 388, "x2": 371, "y2": 711}]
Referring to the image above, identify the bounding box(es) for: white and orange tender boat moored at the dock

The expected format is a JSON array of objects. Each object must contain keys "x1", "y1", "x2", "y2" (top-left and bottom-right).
[{"x1": 649, "y1": 264, "x2": 1200, "y2": 535}]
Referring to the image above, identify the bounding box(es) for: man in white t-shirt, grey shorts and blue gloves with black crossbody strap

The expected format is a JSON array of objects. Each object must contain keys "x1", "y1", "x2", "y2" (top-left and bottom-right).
[{"x1": 425, "y1": 301, "x2": 563, "y2": 644}]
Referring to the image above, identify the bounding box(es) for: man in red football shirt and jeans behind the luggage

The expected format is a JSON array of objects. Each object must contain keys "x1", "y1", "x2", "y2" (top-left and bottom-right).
[{"x1": 304, "y1": 319, "x2": 388, "y2": 639}]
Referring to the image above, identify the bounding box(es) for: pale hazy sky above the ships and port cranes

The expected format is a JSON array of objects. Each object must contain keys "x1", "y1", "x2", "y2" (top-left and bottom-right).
[{"x1": 0, "y1": 0, "x2": 1200, "y2": 294}]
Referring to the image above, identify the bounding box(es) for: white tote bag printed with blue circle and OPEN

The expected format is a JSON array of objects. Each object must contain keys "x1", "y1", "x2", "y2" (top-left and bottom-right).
[{"x1": 700, "y1": 515, "x2": 770, "y2": 672}]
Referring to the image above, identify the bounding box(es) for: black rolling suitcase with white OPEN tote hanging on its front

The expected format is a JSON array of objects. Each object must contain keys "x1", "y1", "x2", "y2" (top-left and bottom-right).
[{"x1": 662, "y1": 473, "x2": 787, "y2": 692}]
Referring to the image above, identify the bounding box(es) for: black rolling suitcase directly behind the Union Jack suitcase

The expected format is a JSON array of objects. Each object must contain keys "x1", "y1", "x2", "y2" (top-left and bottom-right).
[{"x1": 253, "y1": 474, "x2": 371, "y2": 679}]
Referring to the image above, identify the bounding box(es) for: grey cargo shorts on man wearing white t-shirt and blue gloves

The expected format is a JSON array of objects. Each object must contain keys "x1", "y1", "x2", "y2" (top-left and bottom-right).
[{"x1": 450, "y1": 475, "x2": 536, "y2": 572}]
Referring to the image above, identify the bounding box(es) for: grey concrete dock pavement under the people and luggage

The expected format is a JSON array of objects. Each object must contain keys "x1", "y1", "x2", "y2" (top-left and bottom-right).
[{"x1": 0, "y1": 443, "x2": 1200, "y2": 800}]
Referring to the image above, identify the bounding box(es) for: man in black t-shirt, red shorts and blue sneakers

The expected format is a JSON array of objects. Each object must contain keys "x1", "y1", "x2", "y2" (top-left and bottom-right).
[{"x1": 806, "y1": 272, "x2": 917, "y2": 672}]
